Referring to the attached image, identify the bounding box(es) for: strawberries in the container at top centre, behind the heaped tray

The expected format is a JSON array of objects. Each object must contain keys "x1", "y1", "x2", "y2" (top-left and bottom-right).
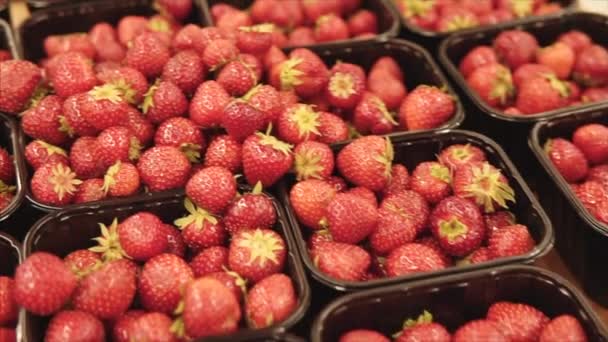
[{"x1": 210, "y1": 0, "x2": 378, "y2": 47}]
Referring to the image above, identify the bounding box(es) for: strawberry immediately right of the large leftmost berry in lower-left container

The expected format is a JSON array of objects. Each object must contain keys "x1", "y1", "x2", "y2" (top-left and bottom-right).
[{"x1": 72, "y1": 259, "x2": 137, "y2": 319}]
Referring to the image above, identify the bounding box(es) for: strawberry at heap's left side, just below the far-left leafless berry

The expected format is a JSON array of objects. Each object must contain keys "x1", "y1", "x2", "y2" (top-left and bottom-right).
[{"x1": 21, "y1": 95, "x2": 68, "y2": 145}]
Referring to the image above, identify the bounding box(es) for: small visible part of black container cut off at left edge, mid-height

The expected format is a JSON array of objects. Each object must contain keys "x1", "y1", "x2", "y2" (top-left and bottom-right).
[{"x1": 0, "y1": 113, "x2": 26, "y2": 223}]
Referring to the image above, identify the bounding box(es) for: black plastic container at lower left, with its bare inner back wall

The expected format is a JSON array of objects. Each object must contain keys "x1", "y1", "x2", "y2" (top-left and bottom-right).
[{"x1": 22, "y1": 192, "x2": 310, "y2": 341}]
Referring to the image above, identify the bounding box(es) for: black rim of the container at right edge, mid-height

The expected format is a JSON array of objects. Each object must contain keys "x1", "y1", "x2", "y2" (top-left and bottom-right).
[{"x1": 528, "y1": 113, "x2": 608, "y2": 237}]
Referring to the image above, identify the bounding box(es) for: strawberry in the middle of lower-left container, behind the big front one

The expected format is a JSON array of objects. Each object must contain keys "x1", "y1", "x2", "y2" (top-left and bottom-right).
[{"x1": 138, "y1": 253, "x2": 194, "y2": 314}]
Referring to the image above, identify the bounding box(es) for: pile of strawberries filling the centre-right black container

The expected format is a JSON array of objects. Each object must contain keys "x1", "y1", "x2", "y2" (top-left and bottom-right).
[{"x1": 289, "y1": 135, "x2": 535, "y2": 281}]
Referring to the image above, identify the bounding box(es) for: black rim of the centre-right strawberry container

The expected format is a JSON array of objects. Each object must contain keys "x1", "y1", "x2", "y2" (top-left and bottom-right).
[{"x1": 280, "y1": 129, "x2": 555, "y2": 292}]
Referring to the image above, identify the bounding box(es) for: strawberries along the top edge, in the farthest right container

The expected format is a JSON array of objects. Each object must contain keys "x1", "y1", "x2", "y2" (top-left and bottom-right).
[{"x1": 393, "y1": 0, "x2": 562, "y2": 32}]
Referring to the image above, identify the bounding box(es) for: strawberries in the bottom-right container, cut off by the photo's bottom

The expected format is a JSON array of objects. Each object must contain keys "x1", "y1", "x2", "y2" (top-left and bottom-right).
[{"x1": 339, "y1": 301, "x2": 587, "y2": 342}]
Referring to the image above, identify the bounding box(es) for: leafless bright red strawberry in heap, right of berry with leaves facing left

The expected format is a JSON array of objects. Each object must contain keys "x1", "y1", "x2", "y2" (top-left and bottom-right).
[{"x1": 189, "y1": 81, "x2": 230, "y2": 128}]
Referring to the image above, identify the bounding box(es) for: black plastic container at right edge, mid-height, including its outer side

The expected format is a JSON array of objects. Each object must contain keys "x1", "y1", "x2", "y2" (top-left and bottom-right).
[{"x1": 529, "y1": 109, "x2": 608, "y2": 306}]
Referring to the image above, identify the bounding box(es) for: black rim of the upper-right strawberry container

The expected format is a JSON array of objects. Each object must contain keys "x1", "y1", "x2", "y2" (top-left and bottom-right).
[{"x1": 439, "y1": 11, "x2": 608, "y2": 123}]
